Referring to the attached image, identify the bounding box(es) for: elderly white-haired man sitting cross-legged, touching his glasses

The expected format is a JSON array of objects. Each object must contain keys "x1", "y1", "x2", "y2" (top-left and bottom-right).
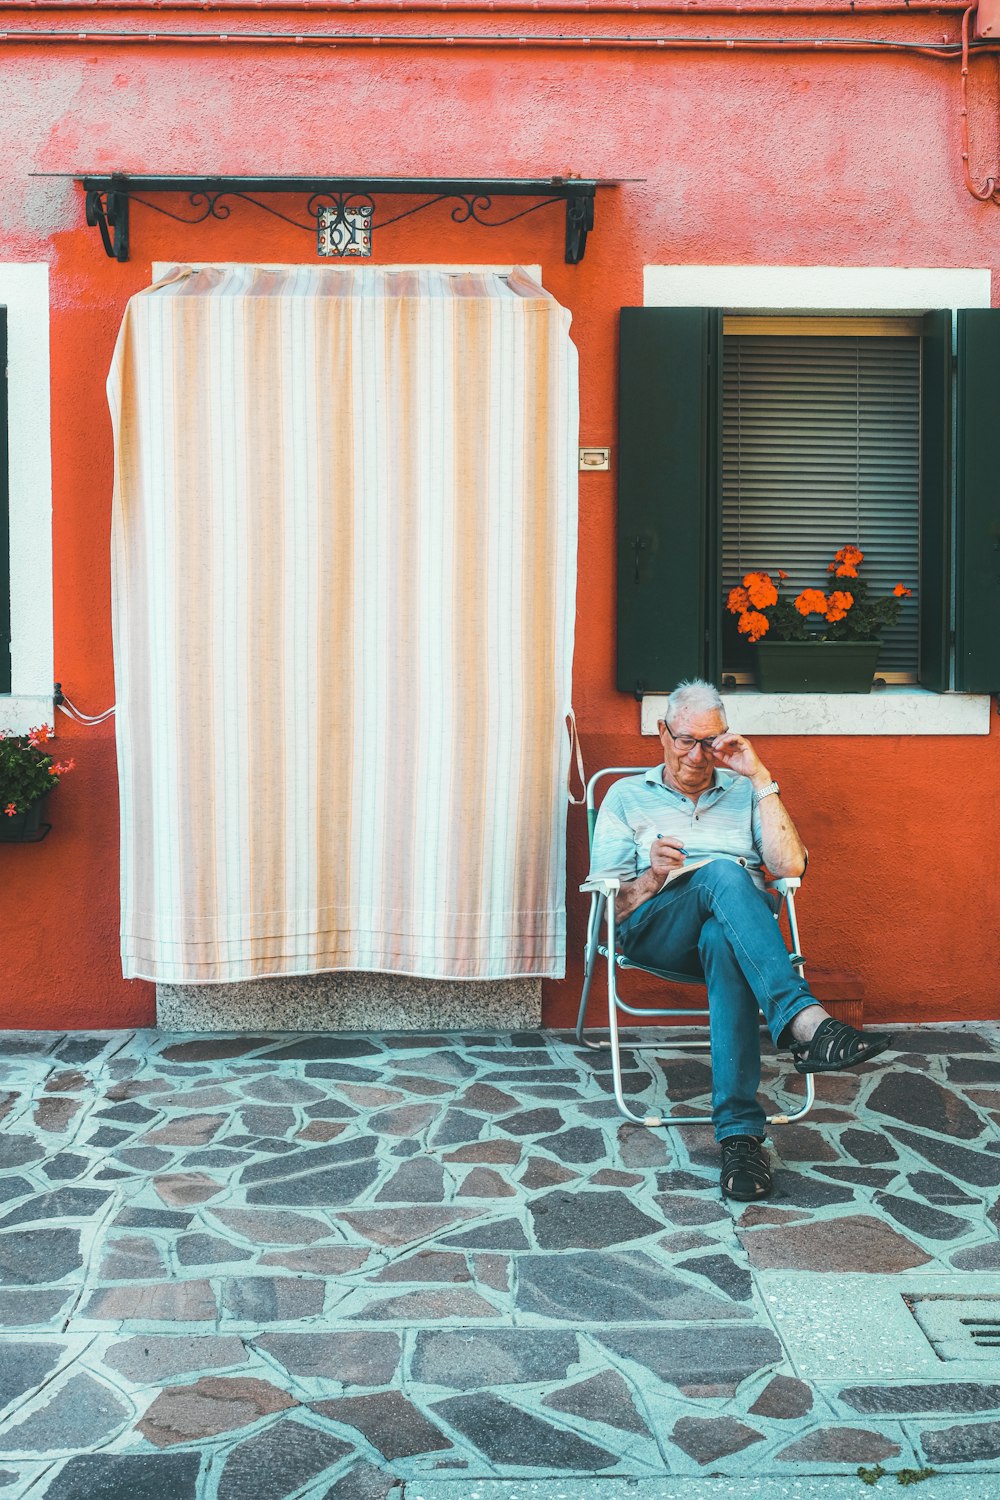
[{"x1": 591, "y1": 681, "x2": 892, "y2": 1202}]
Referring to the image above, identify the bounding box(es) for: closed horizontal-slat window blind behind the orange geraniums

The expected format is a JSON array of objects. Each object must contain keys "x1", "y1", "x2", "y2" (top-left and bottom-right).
[{"x1": 723, "y1": 335, "x2": 921, "y2": 674}]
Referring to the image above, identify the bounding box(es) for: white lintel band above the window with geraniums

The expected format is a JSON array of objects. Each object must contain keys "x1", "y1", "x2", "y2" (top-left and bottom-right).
[{"x1": 643, "y1": 266, "x2": 991, "y2": 315}]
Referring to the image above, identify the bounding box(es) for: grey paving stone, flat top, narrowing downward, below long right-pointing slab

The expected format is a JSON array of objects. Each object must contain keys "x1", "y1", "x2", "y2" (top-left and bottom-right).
[{"x1": 600, "y1": 1326, "x2": 783, "y2": 1395}]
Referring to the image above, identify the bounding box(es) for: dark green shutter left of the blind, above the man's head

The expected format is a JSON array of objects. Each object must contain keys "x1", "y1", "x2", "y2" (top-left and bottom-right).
[{"x1": 616, "y1": 308, "x2": 723, "y2": 693}]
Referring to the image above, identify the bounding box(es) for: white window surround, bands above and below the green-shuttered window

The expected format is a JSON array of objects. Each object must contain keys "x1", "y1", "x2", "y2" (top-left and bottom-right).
[{"x1": 642, "y1": 266, "x2": 993, "y2": 735}]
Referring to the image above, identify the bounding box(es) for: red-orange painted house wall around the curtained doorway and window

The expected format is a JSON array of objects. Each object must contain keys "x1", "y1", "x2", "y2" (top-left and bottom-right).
[{"x1": 0, "y1": 0, "x2": 1000, "y2": 1028}]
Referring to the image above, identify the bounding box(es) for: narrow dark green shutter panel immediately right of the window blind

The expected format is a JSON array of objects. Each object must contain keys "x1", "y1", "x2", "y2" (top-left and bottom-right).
[{"x1": 919, "y1": 312, "x2": 952, "y2": 693}]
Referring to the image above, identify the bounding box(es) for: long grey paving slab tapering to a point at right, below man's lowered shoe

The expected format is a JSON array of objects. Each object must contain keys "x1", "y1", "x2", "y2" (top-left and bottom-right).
[{"x1": 517, "y1": 1250, "x2": 748, "y2": 1323}]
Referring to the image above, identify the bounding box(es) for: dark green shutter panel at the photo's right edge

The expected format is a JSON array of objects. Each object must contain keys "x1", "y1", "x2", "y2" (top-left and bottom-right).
[{"x1": 955, "y1": 308, "x2": 1000, "y2": 693}]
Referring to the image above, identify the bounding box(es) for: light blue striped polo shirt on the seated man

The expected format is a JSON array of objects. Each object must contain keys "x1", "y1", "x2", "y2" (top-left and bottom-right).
[{"x1": 591, "y1": 765, "x2": 765, "y2": 890}]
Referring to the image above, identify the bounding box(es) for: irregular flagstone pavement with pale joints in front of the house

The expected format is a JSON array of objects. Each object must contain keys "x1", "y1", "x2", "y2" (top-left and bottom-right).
[{"x1": 0, "y1": 1025, "x2": 1000, "y2": 1500}]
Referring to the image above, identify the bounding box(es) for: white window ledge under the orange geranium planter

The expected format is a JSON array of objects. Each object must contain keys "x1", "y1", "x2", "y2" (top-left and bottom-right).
[{"x1": 642, "y1": 687, "x2": 991, "y2": 735}]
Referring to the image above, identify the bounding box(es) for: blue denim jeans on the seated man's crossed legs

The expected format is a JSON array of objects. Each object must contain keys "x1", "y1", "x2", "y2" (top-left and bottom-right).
[{"x1": 618, "y1": 860, "x2": 817, "y2": 1140}]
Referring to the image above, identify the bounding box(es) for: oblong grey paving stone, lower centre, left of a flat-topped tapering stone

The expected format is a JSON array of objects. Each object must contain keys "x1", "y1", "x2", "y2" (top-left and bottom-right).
[{"x1": 412, "y1": 1328, "x2": 578, "y2": 1386}]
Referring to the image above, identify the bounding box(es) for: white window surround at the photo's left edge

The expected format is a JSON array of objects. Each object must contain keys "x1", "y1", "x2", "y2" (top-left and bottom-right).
[{"x1": 0, "y1": 263, "x2": 54, "y2": 734}]
